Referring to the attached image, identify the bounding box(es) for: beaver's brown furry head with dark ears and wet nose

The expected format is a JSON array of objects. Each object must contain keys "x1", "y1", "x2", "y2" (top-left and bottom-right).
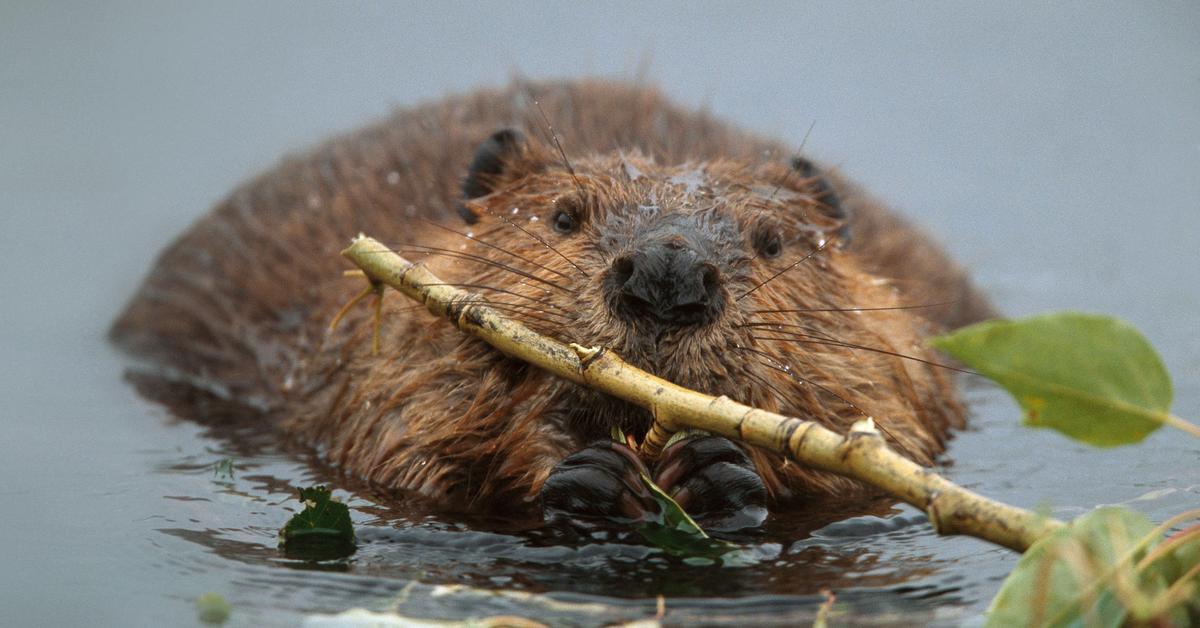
[{"x1": 441, "y1": 130, "x2": 942, "y2": 450}]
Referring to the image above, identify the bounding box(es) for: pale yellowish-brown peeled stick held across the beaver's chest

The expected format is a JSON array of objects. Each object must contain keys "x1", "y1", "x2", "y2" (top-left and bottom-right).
[{"x1": 342, "y1": 237, "x2": 1063, "y2": 551}]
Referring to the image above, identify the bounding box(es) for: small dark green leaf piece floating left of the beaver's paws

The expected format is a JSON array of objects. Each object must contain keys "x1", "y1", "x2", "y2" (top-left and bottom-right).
[{"x1": 280, "y1": 486, "x2": 355, "y2": 561}]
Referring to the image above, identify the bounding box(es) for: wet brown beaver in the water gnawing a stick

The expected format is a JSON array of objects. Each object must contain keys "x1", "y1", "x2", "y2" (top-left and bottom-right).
[{"x1": 110, "y1": 80, "x2": 991, "y2": 527}]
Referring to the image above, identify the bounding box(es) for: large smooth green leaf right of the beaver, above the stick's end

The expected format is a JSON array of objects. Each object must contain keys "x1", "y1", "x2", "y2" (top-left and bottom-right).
[{"x1": 931, "y1": 312, "x2": 1171, "y2": 447}]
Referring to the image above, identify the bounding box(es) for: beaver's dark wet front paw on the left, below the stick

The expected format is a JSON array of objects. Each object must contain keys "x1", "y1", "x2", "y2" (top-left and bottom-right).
[{"x1": 541, "y1": 441, "x2": 659, "y2": 525}]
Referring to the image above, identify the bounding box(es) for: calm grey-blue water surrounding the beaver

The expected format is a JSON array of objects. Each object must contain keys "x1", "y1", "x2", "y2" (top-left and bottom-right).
[{"x1": 0, "y1": 2, "x2": 1200, "y2": 626}]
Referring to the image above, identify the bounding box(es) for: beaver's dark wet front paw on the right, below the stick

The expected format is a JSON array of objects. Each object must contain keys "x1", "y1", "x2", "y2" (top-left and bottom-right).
[{"x1": 653, "y1": 436, "x2": 767, "y2": 532}]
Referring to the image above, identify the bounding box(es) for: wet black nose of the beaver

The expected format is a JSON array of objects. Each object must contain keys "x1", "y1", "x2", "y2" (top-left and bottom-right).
[{"x1": 611, "y1": 243, "x2": 721, "y2": 325}]
